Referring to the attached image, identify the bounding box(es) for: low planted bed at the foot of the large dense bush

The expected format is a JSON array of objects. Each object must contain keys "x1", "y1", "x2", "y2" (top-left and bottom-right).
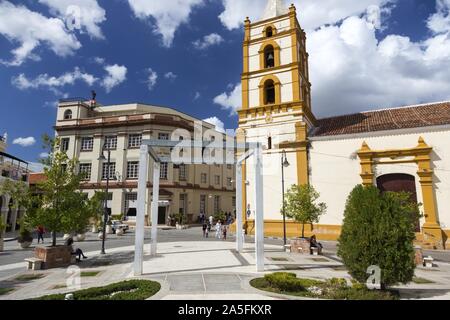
[{"x1": 250, "y1": 272, "x2": 398, "y2": 300}]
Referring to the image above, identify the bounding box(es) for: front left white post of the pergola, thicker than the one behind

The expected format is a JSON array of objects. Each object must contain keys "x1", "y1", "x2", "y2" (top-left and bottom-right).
[{"x1": 134, "y1": 145, "x2": 149, "y2": 276}]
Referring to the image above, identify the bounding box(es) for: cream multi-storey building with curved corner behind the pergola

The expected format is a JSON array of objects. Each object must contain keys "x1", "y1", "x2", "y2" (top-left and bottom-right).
[{"x1": 55, "y1": 99, "x2": 235, "y2": 224}]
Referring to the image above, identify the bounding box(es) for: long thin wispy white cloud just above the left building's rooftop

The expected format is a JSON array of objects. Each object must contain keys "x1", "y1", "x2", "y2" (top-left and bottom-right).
[{"x1": 12, "y1": 67, "x2": 98, "y2": 90}]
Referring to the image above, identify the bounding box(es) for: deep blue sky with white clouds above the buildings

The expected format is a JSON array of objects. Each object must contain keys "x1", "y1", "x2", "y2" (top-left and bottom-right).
[{"x1": 0, "y1": 0, "x2": 450, "y2": 165}]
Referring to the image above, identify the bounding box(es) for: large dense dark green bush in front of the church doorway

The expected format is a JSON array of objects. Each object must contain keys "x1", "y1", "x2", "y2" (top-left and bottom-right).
[{"x1": 338, "y1": 185, "x2": 420, "y2": 288}]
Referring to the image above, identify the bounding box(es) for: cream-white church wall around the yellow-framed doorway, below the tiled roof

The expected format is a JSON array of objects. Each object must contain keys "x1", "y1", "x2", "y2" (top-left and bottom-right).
[{"x1": 310, "y1": 131, "x2": 450, "y2": 229}]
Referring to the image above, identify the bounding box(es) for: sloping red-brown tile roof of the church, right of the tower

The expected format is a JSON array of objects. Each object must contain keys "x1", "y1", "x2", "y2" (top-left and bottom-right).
[{"x1": 313, "y1": 101, "x2": 450, "y2": 137}]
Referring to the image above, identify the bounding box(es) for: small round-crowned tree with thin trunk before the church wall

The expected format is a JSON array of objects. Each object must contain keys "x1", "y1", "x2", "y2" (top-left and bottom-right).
[{"x1": 281, "y1": 184, "x2": 327, "y2": 238}]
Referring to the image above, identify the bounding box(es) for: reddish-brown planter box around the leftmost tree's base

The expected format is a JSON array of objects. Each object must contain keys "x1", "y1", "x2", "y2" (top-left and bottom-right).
[{"x1": 34, "y1": 246, "x2": 72, "y2": 269}]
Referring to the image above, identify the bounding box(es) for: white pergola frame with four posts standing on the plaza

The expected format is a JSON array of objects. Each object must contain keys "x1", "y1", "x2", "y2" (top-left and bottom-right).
[{"x1": 134, "y1": 140, "x2": 264, "y2": 276}]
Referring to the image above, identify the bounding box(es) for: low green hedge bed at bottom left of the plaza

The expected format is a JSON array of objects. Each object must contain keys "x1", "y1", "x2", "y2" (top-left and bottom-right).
[{"x1": 33, "y1": 280, "x2": 161, "y2": 300}]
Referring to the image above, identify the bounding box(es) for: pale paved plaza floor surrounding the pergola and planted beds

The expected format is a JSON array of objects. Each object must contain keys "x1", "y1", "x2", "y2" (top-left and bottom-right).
[{"x1": 0, "y1": 228, "x2": 450, "y2": 300}]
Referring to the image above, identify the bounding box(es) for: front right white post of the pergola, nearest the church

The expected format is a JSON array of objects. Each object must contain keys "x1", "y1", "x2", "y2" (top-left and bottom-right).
[{"x1": 254, "y1": 145, "x2": 264, "y2": 272}]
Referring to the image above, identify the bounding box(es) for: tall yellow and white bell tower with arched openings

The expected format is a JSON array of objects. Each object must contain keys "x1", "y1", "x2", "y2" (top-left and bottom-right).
[{"x1": 237, "y1": 0, "x2": 316, "y2": 228}]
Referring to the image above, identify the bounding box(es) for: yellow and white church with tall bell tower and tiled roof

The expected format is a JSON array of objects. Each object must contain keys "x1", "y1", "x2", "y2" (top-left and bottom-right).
[{"x1": 237, "y1": 0, "x2": 450, "y2": 249}]
